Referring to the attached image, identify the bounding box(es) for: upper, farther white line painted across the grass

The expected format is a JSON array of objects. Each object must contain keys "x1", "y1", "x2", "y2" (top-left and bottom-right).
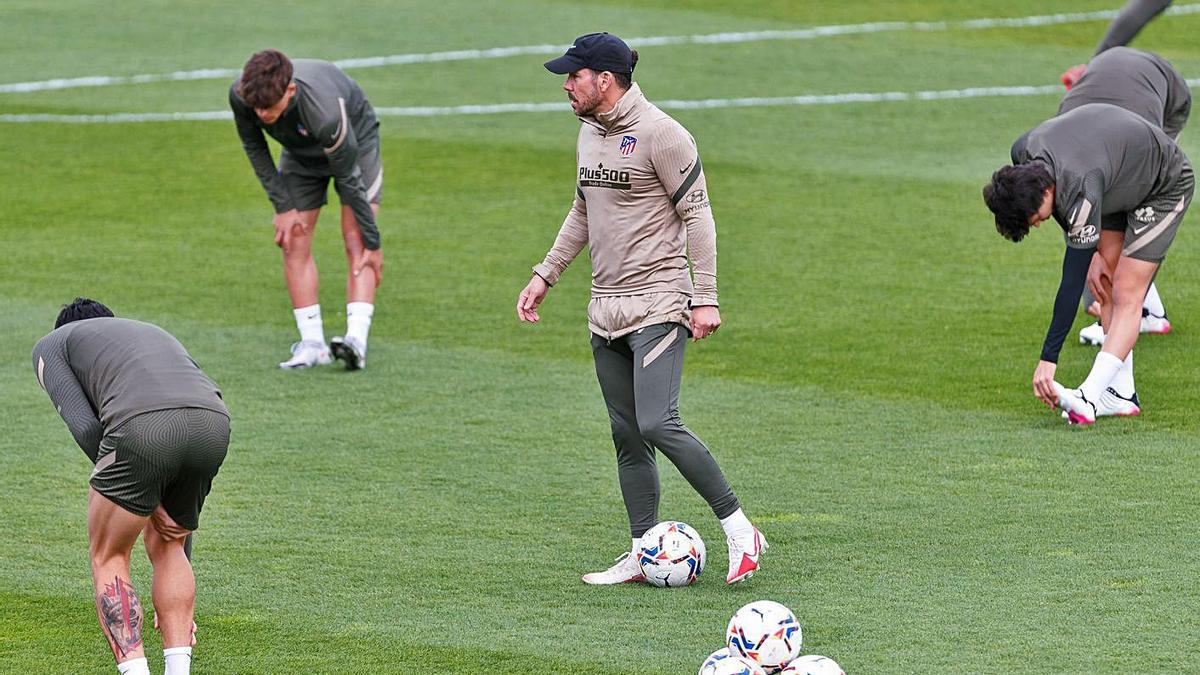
[{"x1": 0, "y1": 4, "x2": 1200, "y2": 94}]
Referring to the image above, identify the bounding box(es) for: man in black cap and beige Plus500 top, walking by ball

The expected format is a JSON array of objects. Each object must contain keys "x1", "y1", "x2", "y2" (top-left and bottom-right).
[{"x1": 516, "y1": 32, "x2": 767, "y2": 584}]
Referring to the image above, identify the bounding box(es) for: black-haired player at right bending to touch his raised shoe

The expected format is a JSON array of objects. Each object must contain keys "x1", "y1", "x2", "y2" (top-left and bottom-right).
[{"x1": 983, "y1": 103, "x2": 1195, "y2": 424}]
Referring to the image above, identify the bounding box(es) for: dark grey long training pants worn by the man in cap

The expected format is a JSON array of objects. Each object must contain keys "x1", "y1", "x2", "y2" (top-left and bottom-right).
[{"x1": 592, "y1": 323, "x2": 739, "y2": 537}]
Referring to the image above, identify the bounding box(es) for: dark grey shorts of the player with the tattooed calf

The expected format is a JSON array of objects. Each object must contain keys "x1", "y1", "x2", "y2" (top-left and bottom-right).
[{"x1": 91, "y1": 408, "x2": 229, "y2": 530}]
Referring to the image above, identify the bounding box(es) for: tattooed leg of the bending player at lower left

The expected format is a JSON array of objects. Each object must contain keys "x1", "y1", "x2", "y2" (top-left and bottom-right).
[{"x1": 88, "y1": 489, "x2": 149, "y2": 674}]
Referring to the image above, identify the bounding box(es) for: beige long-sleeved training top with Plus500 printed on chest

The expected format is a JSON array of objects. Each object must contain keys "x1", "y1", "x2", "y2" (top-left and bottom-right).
[{"x1": 533, "y1": 84, "x2": 718, "y2": 340}]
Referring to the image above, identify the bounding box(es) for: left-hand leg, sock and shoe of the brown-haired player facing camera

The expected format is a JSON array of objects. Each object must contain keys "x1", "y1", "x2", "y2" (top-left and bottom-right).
[{"x1": 278, "y1": 209, "x2": 331, "y2": 369}]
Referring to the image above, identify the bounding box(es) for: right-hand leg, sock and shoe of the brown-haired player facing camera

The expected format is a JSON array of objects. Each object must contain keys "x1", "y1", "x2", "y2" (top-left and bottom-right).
[{"x1": 330, "y1": 204, "x2": 379, "y2": 370}]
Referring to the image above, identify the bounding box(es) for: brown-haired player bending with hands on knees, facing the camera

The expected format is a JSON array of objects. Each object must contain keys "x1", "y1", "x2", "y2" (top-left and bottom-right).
[{"x1": 229, "y1": 49, "x2": 383, "y2": 370}]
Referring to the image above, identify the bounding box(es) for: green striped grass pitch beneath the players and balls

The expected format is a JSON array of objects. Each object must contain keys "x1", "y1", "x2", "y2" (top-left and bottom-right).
[{"x1": 0, "y1": 0, "x2": 1200, "y2": 675}]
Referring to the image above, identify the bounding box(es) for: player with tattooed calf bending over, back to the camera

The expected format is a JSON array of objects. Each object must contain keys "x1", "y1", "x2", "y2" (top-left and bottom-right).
[{"x1": 34, "y1": 298, "x2": 229, "y2": 675}]
